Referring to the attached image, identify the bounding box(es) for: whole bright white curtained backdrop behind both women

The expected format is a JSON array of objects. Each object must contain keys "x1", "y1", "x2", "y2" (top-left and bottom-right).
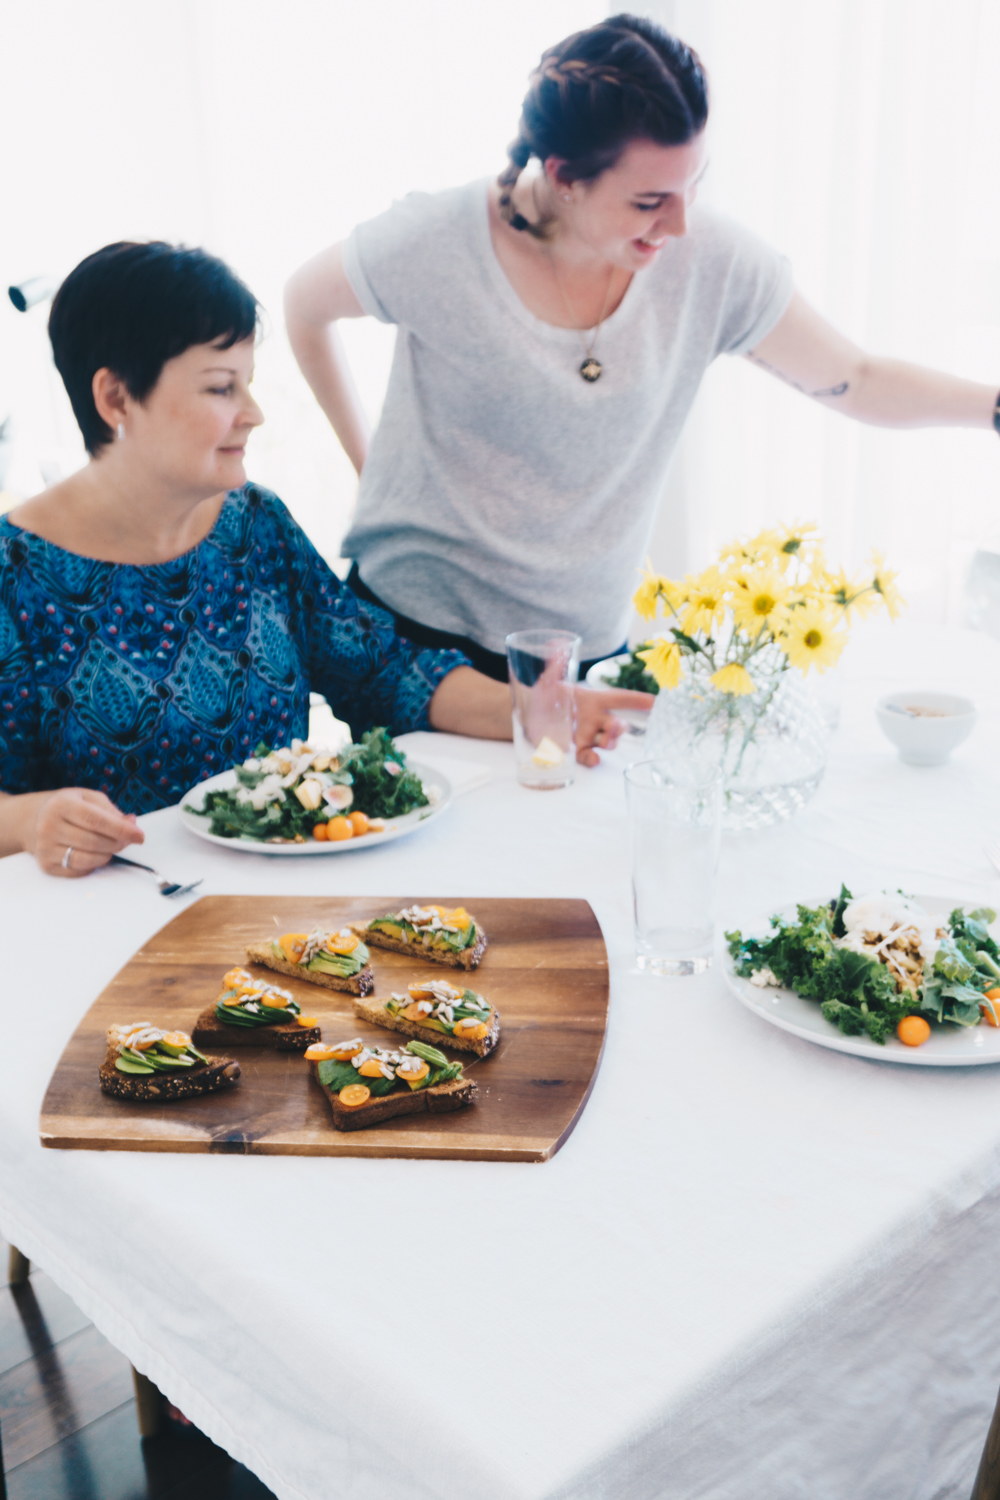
[{"x1": 0, "y1": 0, "x2": 1000, "y2": 621}]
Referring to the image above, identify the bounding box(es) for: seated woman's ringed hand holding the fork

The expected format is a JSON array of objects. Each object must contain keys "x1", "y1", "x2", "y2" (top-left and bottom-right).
[{"x1": 16, "y1": 786, "x2": 145, "y2": 879}]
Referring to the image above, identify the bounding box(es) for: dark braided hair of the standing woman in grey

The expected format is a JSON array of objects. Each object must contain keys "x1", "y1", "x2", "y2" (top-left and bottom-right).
[{"x1": 496, "y1": 15, "x2": 708, "y2": 239}]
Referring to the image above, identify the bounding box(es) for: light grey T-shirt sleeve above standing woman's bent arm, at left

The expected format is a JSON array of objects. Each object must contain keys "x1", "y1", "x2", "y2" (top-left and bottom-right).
[{"x1": 343, "y1": 188, "x2": 469, "y2": 329}]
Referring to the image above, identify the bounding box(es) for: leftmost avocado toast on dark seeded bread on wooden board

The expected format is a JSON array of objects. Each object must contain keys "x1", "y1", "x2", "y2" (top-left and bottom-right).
[{"x1": 97, "y1": 1022, "x2": 240, "y2": 1104}]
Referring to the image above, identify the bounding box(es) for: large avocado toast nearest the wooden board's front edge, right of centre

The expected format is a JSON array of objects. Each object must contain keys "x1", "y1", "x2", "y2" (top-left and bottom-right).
[{"x1": 306, "y1": 1037, "x2": 477, "y2": 1130}]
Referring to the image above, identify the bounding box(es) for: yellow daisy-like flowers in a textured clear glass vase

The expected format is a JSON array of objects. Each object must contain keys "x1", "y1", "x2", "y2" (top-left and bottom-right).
[{"x1": 634, "y1": 525, "x2": 903, "y2": 828}]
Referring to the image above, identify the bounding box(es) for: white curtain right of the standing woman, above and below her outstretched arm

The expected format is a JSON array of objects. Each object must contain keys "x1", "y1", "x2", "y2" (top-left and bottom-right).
[{"x1": 643, "y1": 0, "x2": 1000, "y2": 623}]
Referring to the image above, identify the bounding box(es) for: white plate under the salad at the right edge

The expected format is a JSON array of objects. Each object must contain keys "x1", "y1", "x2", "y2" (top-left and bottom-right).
[{"x1": 723, "y1": 896, "x2": 1000, "y2": 1068}]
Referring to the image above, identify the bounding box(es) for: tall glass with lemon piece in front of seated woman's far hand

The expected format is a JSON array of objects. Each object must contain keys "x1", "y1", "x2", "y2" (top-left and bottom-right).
[{"x1": 507, "y1": 630, "x2": 580, "y2": 791}]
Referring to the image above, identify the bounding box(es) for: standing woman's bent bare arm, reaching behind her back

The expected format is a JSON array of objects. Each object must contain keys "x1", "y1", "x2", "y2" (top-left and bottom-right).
[{"x1": 285, "y1": 245, "x2": 370, "y2": 474}]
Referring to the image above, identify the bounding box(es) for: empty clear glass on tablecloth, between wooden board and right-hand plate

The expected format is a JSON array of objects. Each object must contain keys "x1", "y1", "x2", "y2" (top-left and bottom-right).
[{"x1": 625, "y1": 761, "x2": 723, "y2": 975}]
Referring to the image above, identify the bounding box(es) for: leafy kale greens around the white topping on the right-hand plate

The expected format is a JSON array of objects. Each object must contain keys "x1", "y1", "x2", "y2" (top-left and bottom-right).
[{"x1": 726, "y1": 887, "x2": 1000, "y2": 1044}]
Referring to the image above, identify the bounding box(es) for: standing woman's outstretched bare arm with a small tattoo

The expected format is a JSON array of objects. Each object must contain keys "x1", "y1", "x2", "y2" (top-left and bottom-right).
[{"x1": 747, "y1": 293, "x2": 1000, "y2": 428}]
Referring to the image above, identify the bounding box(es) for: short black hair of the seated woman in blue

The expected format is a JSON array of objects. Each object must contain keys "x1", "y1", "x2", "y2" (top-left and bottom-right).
[{"x1": 48, "y1": 240, "x2": 258, "y2": 455}]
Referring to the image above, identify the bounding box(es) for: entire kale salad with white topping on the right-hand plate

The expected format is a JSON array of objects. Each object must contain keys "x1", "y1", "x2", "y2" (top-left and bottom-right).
[{"x1": 726, "y1": 887, "x2": 1000, "y2": 1047}]
